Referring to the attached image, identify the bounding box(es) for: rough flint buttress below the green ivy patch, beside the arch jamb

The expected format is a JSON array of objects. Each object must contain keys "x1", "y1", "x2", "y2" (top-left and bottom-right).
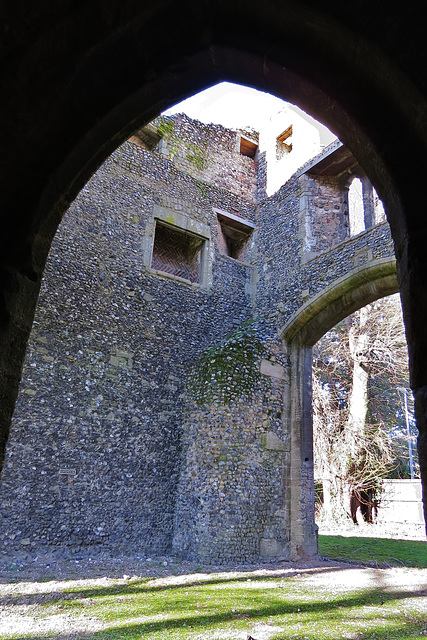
[{"x1": 172, "y1": 390, "x2": 289, "y2": 563}]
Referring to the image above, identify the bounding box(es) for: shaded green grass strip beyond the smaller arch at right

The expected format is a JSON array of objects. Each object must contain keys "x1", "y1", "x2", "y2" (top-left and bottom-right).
[{"x1": 319, "y1": 536, "x2": 427, "y2": 569}]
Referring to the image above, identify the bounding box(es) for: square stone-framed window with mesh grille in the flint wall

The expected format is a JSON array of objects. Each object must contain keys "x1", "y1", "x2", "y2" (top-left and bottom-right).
[{"x1": 151, "y1": 220, "x2": 206, "y2": 284}]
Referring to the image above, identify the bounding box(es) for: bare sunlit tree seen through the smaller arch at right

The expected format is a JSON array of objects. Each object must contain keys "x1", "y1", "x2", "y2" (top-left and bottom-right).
[{"x1": 313, "y1": 296, "x2": 418, "y2": 519}]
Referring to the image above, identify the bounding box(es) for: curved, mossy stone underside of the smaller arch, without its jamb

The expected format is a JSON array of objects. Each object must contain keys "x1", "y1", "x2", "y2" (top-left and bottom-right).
[{"x1": 280, "y1": 259, "x2": 399, "y2": 347}]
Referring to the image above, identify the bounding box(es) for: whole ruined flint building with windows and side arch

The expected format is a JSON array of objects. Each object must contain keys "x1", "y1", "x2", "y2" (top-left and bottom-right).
[{"x1": 0, "y1": 116, "x2": 397, "y2": 562}]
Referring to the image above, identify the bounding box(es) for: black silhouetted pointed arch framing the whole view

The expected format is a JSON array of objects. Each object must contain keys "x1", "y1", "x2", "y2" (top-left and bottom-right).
[{"x1": 0, "y1": 0, "x2": 427, "y2": 528}]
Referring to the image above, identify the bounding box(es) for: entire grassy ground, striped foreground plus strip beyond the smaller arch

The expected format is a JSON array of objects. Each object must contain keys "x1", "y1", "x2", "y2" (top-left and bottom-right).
[{"x1": 0, "y1": 536, "x2": 427, "y2": 640}]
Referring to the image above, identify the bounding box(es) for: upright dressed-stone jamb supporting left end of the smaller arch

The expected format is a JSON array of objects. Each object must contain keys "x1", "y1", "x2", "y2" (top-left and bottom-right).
[{"x1": 285, "y1": 342, "x2": 317, "y2": 560}]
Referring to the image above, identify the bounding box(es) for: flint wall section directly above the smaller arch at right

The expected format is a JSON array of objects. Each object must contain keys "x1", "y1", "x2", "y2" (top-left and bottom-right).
[{"x1": 256, "y1": 175, "x2": 395, "y2": 329}]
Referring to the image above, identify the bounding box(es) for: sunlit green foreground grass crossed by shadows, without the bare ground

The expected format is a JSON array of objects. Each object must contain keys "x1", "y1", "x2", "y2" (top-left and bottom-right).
[{"x1": 4, "y1": 574, "x2": 427, "y2": 640}]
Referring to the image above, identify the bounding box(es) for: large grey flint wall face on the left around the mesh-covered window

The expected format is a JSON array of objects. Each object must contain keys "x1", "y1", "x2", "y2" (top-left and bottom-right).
[{"x1": 0, "y1": 127, "x2": 262, "y2": 554}]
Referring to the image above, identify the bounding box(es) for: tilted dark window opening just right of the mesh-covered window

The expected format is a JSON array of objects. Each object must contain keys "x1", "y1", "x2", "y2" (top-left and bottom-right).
[{"x1": 217, "y1": 211, "x2": 254, "y2": 262}]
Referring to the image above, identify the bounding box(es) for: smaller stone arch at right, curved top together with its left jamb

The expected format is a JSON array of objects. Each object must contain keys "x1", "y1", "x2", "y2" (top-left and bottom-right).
[{"x1": 281, "y1": 260, "x2": 398, "y2": 557}]
